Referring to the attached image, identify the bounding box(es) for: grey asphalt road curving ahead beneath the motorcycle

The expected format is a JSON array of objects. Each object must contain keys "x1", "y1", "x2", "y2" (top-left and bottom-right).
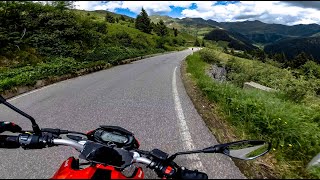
[{"x1": 0, "y1": 49, "x2": 245, "y2": 179}]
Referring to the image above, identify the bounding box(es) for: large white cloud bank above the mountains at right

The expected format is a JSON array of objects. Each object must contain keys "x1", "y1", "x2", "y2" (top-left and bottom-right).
[{"x1": 181, "y1": 1, "x2": 320, "y2": 25}]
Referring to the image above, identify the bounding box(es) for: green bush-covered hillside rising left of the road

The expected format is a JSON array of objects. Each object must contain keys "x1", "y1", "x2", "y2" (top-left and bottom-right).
[{"x1": 0, "y1": 1, "x2": 195, "y2": 92}]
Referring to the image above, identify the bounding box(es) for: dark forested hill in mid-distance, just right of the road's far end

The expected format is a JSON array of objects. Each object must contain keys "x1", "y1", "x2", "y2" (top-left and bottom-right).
[{"x1": 204, "y1": 29, "x2": 258, "y2": 51}]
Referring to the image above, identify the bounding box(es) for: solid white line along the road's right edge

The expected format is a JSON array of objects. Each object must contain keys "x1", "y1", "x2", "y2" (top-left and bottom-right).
[{"x1": 172, "y1": 67, "x2": 204, "y2": 170}]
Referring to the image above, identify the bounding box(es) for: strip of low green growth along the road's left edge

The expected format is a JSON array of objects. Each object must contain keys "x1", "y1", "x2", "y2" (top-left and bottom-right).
[{"x1": 0, "y1": 48, "x2": 178, "y2": 98}]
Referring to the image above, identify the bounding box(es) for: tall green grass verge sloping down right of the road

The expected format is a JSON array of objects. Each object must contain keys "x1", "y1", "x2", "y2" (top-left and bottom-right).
[{"x1": 186, "y1": 50, "x2": 320, "y2": 178}]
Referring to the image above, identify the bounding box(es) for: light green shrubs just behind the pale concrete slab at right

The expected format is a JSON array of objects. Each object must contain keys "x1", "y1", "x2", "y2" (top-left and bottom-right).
[{"x1": 221, "y1": 49, "x2": 316, "y2": 102}]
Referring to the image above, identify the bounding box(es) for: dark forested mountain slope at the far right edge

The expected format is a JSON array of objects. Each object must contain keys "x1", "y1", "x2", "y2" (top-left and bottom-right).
[{"x1": 264, "y1": 36, "x2": 320, "y2": 63}]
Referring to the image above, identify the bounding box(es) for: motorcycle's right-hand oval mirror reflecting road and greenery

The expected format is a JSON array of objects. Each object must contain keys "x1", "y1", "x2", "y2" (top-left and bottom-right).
[{"x1": 221, "y1": 140, "x2": 271, "y2": 160}]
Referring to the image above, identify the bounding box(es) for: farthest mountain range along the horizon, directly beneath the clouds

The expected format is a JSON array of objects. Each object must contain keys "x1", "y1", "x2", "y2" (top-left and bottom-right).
[{"x1": 150, "y1": 16, "x2": 320, "y2": 45}]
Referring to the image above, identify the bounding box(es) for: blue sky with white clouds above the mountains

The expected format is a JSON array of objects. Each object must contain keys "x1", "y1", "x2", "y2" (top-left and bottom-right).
[{"x1": 75, "y1": 1, "x2": 320, "y2": 25}]
